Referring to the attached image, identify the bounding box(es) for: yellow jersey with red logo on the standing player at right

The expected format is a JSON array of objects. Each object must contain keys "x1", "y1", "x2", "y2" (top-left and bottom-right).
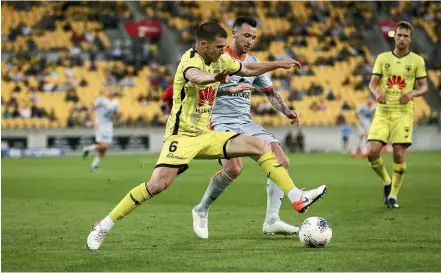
[{"x1": 372, "y1": 51, "x2": 427, "y2": 114}]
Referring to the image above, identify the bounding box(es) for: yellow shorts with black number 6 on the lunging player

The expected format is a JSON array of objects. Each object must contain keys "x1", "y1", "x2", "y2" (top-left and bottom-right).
[{"x1": 155, "y1": 131, "x2": 240, "y2": 174}]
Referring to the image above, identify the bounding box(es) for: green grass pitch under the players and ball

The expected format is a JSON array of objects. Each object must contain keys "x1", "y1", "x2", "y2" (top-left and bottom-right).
[{"x1": 1, "y1": 153, "x2": 441, "y2": 272}]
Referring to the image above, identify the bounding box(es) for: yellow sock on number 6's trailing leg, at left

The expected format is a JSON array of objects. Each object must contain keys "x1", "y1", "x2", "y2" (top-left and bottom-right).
[{"x1": 109, "y1": 183, "x2": 153, "y2": 222}]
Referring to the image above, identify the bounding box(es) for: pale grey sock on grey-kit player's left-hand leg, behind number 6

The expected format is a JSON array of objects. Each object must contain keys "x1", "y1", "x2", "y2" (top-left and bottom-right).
[{"x1": 196, "y1": 170, "x2": 234, "y2": 212}]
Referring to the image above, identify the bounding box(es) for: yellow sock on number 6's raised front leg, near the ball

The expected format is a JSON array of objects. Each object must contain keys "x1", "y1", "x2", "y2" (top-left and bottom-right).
[{"x1": 257, "y1": 152, "x2": 295, "y2": 195}]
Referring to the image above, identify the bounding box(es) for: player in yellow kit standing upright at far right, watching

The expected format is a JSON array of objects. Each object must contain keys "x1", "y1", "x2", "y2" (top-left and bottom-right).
[{"x1": 368, "y1": 21, "x2": 427, "y2": 208}]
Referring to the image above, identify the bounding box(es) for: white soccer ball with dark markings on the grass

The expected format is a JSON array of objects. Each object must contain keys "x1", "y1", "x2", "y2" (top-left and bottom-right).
[{"x1": 299, "y1": 217, "x2": 332, "y2": 247}]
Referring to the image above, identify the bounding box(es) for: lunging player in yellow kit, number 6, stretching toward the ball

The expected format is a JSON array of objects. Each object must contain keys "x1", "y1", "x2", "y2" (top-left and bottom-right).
[{"x1": 87, "y1": 22, "x2": 326, "y2": 250}]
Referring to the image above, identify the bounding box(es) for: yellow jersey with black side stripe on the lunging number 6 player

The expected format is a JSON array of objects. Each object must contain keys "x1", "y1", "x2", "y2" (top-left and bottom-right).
[{"x1": 164, "y1": 48, "x2": 242, "y2": 138}]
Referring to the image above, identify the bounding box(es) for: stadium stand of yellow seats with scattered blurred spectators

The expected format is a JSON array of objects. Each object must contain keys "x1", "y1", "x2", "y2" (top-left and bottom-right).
[{"x1": 1, "y1": 1, "x2": 441, "y2": 128}]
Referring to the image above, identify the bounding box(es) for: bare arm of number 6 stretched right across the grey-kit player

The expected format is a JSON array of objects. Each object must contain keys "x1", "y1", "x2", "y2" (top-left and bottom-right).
[{"x1": 237, "y1": 59, "x2": 302, "y2": 77}]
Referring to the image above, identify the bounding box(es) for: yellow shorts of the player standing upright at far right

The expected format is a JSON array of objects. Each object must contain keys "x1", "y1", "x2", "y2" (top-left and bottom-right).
[{"x1": 368, "y1": 114, "x2": 413, "y2": 146}]
